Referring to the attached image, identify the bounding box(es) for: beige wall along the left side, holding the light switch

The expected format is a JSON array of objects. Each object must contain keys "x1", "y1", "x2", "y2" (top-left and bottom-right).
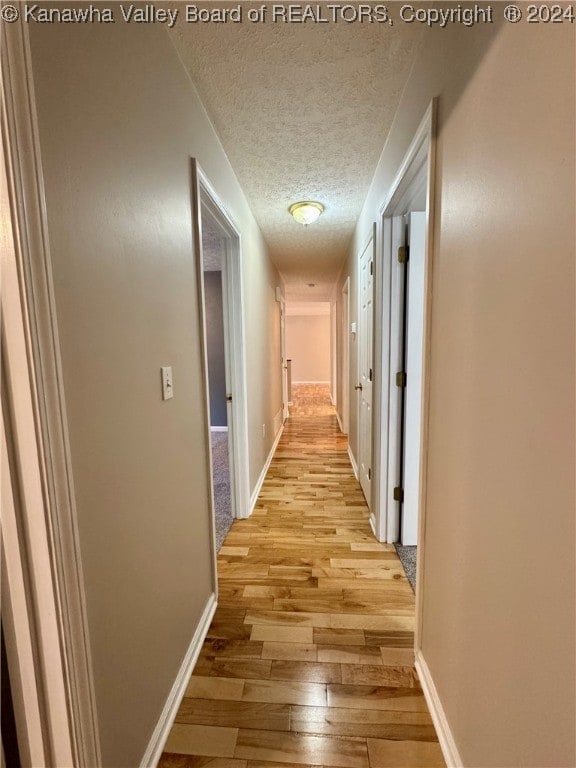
[{"x1": 30, "y1": 24, "x2": 281, "y2": 766}]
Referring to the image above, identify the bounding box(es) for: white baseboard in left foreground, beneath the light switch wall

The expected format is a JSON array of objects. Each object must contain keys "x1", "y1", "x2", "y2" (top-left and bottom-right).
[{"x1": 140, "y1": 592, "x2": 217, "y2": 768}]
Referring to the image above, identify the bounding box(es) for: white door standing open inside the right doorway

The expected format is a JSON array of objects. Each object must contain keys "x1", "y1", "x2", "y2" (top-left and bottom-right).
[{"x1": 401, "y1": 213, "x2": 426, "y2": 545}]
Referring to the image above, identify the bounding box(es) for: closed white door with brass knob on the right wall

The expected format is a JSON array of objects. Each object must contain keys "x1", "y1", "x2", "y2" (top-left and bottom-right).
[{"x1": 356, "y1": 238, "x2": 374, "y2": 508}]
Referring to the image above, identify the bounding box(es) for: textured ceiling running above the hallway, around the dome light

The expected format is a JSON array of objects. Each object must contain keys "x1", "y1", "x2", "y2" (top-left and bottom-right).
[{"x1": 171, "y1": 2, "x2": 421, "y2": 300}]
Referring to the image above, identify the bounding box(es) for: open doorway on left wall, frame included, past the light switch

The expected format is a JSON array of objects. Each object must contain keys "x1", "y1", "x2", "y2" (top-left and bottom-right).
[{"x1": 194, "y1": 164, "x2": 249, "y2": 553}]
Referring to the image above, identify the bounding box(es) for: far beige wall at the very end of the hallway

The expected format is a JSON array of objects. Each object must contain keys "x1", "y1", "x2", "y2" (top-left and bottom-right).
[{"x1": 286, "y1": 315, "x2": 330, "y2": 382}]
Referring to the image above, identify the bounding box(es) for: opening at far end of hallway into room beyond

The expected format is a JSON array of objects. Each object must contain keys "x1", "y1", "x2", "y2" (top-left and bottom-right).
[{"x1": 284, "y1": 301, "x2": 335, "y2": 414}]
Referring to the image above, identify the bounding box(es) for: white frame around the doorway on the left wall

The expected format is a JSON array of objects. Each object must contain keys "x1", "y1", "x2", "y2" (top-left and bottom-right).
[{"x1": 192, "y1": 159, "x2": 250, "y2": 536}]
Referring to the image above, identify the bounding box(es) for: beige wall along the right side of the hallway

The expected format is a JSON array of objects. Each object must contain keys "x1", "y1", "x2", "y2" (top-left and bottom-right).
[{"x1": 345, "y1": 18, "x2": 575, "y2": 768}]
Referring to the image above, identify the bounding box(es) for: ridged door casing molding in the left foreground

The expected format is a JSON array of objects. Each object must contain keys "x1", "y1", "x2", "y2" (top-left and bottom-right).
[{"x1": 1, "y1": 19, "x2": 101, "y2": 768}]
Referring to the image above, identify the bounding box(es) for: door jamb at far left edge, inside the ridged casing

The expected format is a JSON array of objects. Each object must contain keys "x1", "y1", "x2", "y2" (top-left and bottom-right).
[{"x1": 0, "y1": 148, "x2": 76, "y2": 768}]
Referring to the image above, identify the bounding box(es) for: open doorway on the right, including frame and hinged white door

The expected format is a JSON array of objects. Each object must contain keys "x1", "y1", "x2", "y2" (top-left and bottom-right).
[{"x1": 376, "y1": 103, "x2": 434, "y2": 649}]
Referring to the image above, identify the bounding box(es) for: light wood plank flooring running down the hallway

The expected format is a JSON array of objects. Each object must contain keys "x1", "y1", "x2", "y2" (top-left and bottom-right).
[{"x1": 159, "y1": 386, "x2": 445, "y2": 768}]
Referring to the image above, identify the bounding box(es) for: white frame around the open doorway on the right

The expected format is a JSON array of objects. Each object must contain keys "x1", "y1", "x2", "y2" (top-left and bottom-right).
[{"x1": 374, "y1": 100, "x2": 436, "y2": 650}]
